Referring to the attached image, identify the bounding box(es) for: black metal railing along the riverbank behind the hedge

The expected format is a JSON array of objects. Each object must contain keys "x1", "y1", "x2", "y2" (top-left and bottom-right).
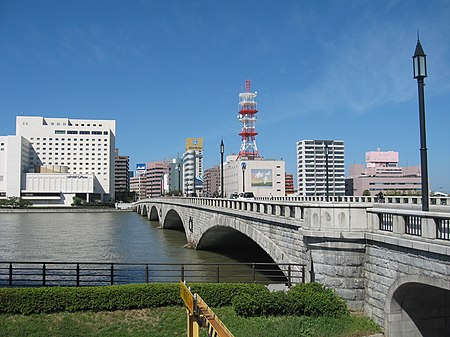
[{"x1": 0, "y1": 262, "x2": 305, "y2": 287}]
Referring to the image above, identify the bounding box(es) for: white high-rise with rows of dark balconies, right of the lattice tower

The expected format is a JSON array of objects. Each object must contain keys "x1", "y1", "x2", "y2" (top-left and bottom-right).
[{"x1": 297, "y1": 140, "x2": 345, "y2": 196}]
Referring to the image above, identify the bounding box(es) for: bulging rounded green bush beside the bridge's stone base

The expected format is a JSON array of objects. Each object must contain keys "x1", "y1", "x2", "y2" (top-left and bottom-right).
[{"x1": 232, "y1": 283, "x2": 349, "y2": 317}]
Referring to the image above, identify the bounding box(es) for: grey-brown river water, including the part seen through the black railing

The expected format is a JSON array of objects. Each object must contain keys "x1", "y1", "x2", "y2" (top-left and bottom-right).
[{"x1": 0, "y1": 212, "x2": 283, "y2": 286}]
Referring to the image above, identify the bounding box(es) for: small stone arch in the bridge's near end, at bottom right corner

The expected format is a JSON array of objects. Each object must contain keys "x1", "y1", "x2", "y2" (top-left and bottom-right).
[{"x1": 385, "y1": 276, "x2": 450, "y2": 337}]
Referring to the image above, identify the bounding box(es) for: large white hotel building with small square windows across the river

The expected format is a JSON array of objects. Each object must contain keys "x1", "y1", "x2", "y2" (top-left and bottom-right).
[{"x1": 0, "y1": 116, "x2": 116, "y2": 206}]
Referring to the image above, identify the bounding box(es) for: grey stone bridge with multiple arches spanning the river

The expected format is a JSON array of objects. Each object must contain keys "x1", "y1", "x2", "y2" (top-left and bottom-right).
[{"x1": 134, "y1": 197, "x2": 450, "y2": 337}]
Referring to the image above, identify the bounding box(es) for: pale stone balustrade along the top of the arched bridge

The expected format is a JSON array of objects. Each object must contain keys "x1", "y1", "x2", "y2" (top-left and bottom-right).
[{"x1": 137, "y1": 197, "x2": 450, "y2": 244}]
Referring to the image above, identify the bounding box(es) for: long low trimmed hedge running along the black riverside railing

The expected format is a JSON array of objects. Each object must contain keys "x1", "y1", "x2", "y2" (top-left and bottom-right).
[{"x1": 0, "y1": 283, "x2": 269, "y2": 315}]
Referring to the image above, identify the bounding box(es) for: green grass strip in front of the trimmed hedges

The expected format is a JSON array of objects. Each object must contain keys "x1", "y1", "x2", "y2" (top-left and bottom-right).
[{"x1": 0, "y1": 307, "x2": 380, "y2": 337}]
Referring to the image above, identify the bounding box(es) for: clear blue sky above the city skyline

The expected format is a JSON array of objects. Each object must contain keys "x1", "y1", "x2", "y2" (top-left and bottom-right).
[{"x1": 0, "y1": 0, "x2": 450, "y2": 192}]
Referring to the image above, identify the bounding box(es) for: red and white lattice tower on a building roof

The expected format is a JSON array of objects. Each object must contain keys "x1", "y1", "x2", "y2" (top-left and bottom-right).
[{"x1": 237, "y1": 80, "x2": 261, "y2": 160}]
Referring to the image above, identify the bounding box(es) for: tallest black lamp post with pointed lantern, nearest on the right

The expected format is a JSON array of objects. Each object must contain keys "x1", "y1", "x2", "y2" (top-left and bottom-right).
[{"x1": 413, "y1": 36, "x2": 430, "y2": 211}]
